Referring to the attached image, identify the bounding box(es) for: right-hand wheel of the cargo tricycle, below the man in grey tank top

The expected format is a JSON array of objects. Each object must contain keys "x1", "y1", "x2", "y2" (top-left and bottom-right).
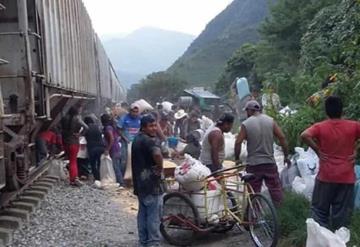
[{"x1": 247, "y1": 194, "x2": 279, "y2": 247}]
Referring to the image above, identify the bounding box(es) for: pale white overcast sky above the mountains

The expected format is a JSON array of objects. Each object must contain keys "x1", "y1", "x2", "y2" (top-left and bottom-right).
[{"x1": 83, "y1": 0, "x2": 232, "y2": 36}]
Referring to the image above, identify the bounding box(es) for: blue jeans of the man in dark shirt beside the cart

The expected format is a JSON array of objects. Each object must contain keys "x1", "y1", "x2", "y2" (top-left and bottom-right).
[{"x1": 137, "y1": 195, "x2": 162, "y2": 247}]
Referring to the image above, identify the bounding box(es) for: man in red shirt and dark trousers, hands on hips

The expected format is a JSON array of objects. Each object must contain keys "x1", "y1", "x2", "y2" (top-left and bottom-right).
[{"x1": 301, "y1": 96, "x2": 360, "y2": 229}]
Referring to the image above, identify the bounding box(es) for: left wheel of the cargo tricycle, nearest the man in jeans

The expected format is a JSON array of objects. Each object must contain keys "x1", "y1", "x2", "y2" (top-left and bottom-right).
[{"x1": 160, "y1": 192, "x2": 199, "y2": 246}]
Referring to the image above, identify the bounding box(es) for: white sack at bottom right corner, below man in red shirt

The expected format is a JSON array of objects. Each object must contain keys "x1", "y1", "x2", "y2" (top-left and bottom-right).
[{"x1": 306, "y1": 219, "x2": 350, "y2": 247}]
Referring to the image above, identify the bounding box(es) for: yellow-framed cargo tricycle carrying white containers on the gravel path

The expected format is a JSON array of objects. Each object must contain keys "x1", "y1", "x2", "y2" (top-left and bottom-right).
[{"x1": 160, "y1": 165, "x2": 279, "y2": 247}]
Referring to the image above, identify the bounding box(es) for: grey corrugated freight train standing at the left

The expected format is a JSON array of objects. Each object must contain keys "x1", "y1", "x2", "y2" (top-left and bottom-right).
[{"x1": 0, "y1": 0, "x2": 126, "y2": 190}]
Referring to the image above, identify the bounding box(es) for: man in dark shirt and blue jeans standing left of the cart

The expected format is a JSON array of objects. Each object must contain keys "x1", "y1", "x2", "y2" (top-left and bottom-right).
[{"x1": 131, "y1": 114, "x2": 164, "y2": 246}]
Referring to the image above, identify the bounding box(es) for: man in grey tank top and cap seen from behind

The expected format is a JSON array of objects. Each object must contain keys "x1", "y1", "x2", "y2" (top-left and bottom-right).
[{"x1": 235, "y1": 100, "x2": 290, "y2": 206}]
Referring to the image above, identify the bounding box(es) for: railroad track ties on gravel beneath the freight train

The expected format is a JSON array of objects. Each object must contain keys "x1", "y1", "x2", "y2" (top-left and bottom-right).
[{"x1": 0, "y1": 162, "x2": 59, "y2": 247}]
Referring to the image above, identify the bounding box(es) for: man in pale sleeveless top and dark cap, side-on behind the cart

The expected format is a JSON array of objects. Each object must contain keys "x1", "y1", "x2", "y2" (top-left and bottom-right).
[{"x1": 200, "y1": 113, "x2": 234, "y2": 172}]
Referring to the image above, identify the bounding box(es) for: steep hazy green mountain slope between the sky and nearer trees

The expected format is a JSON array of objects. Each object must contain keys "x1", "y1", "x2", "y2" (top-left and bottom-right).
[{"x1": 168, "y1": 0, "x2": 271, "y2": 86}]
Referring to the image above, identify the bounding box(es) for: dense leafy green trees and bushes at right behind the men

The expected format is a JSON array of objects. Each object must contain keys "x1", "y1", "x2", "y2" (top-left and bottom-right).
[{"x1": 216, "y1": 0, "x2": 360, "y2": 154}]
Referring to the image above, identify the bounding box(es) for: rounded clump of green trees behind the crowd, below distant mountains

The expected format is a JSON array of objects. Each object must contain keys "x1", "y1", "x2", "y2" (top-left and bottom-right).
[{"x1": 128, "y1": 72, "x2": 188, "y2": 105}]
